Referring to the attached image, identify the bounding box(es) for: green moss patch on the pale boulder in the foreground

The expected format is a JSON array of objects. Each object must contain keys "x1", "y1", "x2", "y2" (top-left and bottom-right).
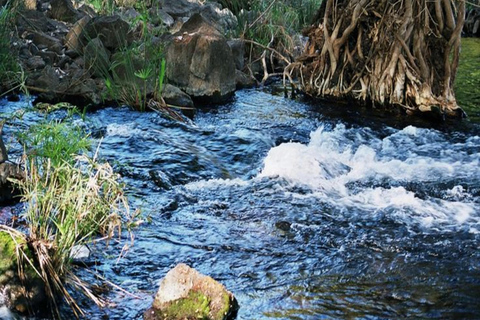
[{"x1": 156, "y1": 291, "x2": 213, "y2": 320}]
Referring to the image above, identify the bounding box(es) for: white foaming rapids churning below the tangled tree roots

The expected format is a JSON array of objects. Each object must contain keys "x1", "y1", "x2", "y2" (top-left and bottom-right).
[{"x1": 259, "y1": 125, "x2": 480, "y2": 232}]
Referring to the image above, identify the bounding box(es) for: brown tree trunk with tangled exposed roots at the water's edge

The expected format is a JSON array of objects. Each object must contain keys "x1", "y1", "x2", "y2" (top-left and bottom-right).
[{"x1": 296, "y1": 0, "x2": 465, "y2": 117}]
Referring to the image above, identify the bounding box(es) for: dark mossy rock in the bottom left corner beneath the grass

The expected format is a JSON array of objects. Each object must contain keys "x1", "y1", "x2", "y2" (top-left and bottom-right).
[{"x1": 0, "y1": 231, "x2": 46, "y2": 313}]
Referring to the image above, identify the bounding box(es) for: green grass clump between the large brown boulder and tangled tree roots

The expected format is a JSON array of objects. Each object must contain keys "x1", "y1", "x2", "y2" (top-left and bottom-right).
[{"x1": 220, "y1": 0, "x2": 322, "y2": 83}]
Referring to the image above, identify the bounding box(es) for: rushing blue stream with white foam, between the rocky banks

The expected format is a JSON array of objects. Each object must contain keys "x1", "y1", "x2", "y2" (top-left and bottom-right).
[{"x1": 0, "y1": 90, "x2": 480, "y2": 320}]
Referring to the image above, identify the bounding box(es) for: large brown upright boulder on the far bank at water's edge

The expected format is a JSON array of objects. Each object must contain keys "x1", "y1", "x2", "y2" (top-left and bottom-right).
[{"x1": 166, "y1": 14, "x2": 235, "y2": 103}]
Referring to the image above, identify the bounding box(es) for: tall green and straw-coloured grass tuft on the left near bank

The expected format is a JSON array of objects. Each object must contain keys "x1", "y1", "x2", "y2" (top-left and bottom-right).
[{"x1": 11, "y1": 117, "x2": 129, "y2": 318}]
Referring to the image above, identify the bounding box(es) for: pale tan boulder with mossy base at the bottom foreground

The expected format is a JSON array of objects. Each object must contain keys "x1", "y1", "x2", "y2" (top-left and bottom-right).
[{"x1": 144, "y1": 263, "x2": 238, "y2": 320}]
